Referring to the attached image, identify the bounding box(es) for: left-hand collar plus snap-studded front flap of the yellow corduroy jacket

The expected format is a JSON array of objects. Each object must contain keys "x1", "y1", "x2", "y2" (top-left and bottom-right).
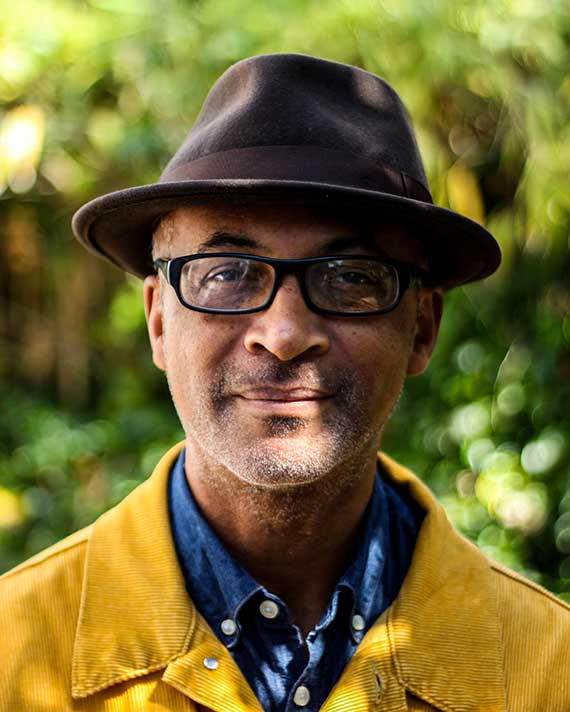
[{"x1": 71, "y1": 443, "x2": 262, "y2": 712}]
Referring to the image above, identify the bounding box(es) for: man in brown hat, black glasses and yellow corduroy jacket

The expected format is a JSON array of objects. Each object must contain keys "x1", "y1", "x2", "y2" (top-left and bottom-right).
[{"x1": 0, "y1": 55, "x2": 570, "y2": 712}]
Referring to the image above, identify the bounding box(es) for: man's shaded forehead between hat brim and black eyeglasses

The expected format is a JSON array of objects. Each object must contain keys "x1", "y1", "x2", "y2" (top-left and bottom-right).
[{"x1": 153, "y1": 203, "x2": 427, "y2": 265}]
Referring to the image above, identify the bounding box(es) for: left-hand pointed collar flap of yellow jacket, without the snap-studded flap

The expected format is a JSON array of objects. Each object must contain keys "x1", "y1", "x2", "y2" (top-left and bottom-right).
[{"x1": 72, "y1": 446, "x2": 191, "y2": 698}]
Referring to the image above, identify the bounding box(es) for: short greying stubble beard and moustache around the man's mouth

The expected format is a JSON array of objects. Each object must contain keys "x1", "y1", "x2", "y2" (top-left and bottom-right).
[{"x1": 180, "y1": 364, "x2": 395, "y2": 495}]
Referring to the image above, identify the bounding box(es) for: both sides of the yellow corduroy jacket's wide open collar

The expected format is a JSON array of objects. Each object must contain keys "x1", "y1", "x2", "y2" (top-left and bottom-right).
[{"x1": 72, "y1": 444, "x2": 506, "y2": 712}]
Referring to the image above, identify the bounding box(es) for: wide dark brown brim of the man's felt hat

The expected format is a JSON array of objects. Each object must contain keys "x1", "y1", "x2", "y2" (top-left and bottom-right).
[{"x1": 72, "y1": 179, "x2": 501, "y2": 288}]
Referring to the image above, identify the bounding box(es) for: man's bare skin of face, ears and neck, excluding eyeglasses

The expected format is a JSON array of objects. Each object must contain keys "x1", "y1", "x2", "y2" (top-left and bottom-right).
[{"x1": 144, "y1": 205, "x2": 443, "y2": 634}]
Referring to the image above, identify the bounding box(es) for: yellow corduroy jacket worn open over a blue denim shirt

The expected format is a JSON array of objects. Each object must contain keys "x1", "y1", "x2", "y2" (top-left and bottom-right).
[{"x1": 0, "y1": 446, "x2": 570, "y2": 712}]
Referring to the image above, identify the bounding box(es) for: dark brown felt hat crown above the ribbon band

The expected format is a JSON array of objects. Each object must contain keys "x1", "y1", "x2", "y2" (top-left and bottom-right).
[{"x1": 161, "y1": 54, "x2": 429, "y2": 190}]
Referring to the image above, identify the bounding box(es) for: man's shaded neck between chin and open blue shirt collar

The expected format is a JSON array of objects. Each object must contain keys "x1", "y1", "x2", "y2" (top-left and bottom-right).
[{"x1": 186, "y1": 445, "x2": 376, "y2": 635}]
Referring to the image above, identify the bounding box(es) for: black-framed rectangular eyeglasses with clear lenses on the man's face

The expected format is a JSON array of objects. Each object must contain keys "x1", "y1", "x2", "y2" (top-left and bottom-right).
[{"x1": 154, "y1": 252, "x2": 420, "y2": 316}]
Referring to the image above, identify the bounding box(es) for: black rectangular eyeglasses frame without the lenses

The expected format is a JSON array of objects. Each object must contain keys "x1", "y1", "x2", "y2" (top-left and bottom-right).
[{"x1": 153, "y1": 252, "x2": 422, "y2": 317}]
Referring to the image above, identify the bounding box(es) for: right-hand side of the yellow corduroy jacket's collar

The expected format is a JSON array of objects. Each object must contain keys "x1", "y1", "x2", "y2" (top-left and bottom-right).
[{"x1": 361, "y1": 454, "x2": 506, "y2": 712}]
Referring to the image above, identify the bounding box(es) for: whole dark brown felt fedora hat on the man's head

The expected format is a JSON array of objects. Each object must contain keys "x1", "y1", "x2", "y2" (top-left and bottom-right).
[{"x1": 73, "y1": 54, "x2": 501, "y2": 287}]
